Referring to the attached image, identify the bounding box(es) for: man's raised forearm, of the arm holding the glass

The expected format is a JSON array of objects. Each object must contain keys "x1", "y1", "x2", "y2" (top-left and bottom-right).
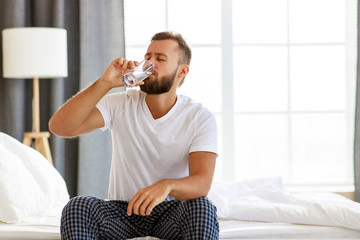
[{"x1": 49, "y1": 79, "x2": 111, "y2": 136}]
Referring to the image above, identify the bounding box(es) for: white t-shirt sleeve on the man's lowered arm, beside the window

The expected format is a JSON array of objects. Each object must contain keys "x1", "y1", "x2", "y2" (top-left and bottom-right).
[{"x1": 190, "y1": 111, "x2": 218, "y2": 155}]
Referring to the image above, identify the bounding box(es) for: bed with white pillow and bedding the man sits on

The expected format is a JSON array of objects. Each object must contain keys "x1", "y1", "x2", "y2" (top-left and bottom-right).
[{"x1": 0, "y1": 133, "x2": 360, "y2": 240}]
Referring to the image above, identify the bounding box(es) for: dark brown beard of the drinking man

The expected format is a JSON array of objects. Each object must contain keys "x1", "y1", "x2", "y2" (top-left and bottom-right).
[{"x1": 140, "y1": 69, "x2": 177, "y2": 94}]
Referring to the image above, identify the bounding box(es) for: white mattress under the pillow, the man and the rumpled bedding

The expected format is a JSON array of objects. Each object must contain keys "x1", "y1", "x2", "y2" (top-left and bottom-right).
[{"x1": 0, "y1": 218, "x2": 360, "y2": 240}]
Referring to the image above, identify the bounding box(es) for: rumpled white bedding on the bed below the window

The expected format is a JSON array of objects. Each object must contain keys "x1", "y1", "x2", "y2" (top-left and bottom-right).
[{"x1": 209, "y1": 178, "x2": 360, "y2": 230}]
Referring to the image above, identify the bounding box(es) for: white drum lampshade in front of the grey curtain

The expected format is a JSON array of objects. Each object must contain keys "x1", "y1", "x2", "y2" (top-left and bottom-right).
[{"x1": 2, "y1": 27, "x2": 68, "y2": 78}]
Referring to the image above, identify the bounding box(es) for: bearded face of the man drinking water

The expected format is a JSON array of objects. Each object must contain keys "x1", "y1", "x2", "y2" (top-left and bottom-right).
[{"x1": 140, "y1": 40, "x2": 179, "y2": 94}]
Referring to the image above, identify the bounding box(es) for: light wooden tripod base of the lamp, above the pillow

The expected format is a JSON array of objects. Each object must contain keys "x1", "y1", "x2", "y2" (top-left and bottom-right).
[{"x1": 23, "y1": 132, "x2": 54, "y2": 165}]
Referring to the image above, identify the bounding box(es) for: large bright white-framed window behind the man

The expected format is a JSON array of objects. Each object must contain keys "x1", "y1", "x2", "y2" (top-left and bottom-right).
[{"x1": 124, "y1": 0, "x2": 357, "y2": 191}]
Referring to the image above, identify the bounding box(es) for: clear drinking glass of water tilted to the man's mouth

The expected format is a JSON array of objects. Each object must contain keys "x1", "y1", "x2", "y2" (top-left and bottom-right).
[{"x1": 122, "y1": 60, "x2": 154, "y2": 87}]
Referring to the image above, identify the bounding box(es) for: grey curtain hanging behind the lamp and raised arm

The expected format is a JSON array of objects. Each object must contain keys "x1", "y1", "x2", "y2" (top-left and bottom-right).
[{"x1": 0, "y1": 0, "x2": 125, "y2": 198}]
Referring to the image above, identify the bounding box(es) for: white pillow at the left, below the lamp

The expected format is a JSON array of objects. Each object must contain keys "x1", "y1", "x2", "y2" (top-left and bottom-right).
[{"x1": 0, "y1": 132, "x2": 69, "y2": 223}]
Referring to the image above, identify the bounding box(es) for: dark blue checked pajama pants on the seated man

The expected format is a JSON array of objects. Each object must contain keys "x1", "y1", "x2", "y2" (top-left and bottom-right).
[{"x1": 61, "y1": 196, "x2": 219, "y2": 240}]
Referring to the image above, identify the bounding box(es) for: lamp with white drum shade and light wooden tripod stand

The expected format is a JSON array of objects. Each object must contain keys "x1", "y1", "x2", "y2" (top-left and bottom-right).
[{"x1": 2, "y1": 27, "x2": 68, "y2": 163}]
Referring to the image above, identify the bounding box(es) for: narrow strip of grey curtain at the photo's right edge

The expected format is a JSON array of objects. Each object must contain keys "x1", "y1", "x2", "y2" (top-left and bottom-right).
[{"x1": 354, "y1": 0, "x2": 360, "y2": 202}]
